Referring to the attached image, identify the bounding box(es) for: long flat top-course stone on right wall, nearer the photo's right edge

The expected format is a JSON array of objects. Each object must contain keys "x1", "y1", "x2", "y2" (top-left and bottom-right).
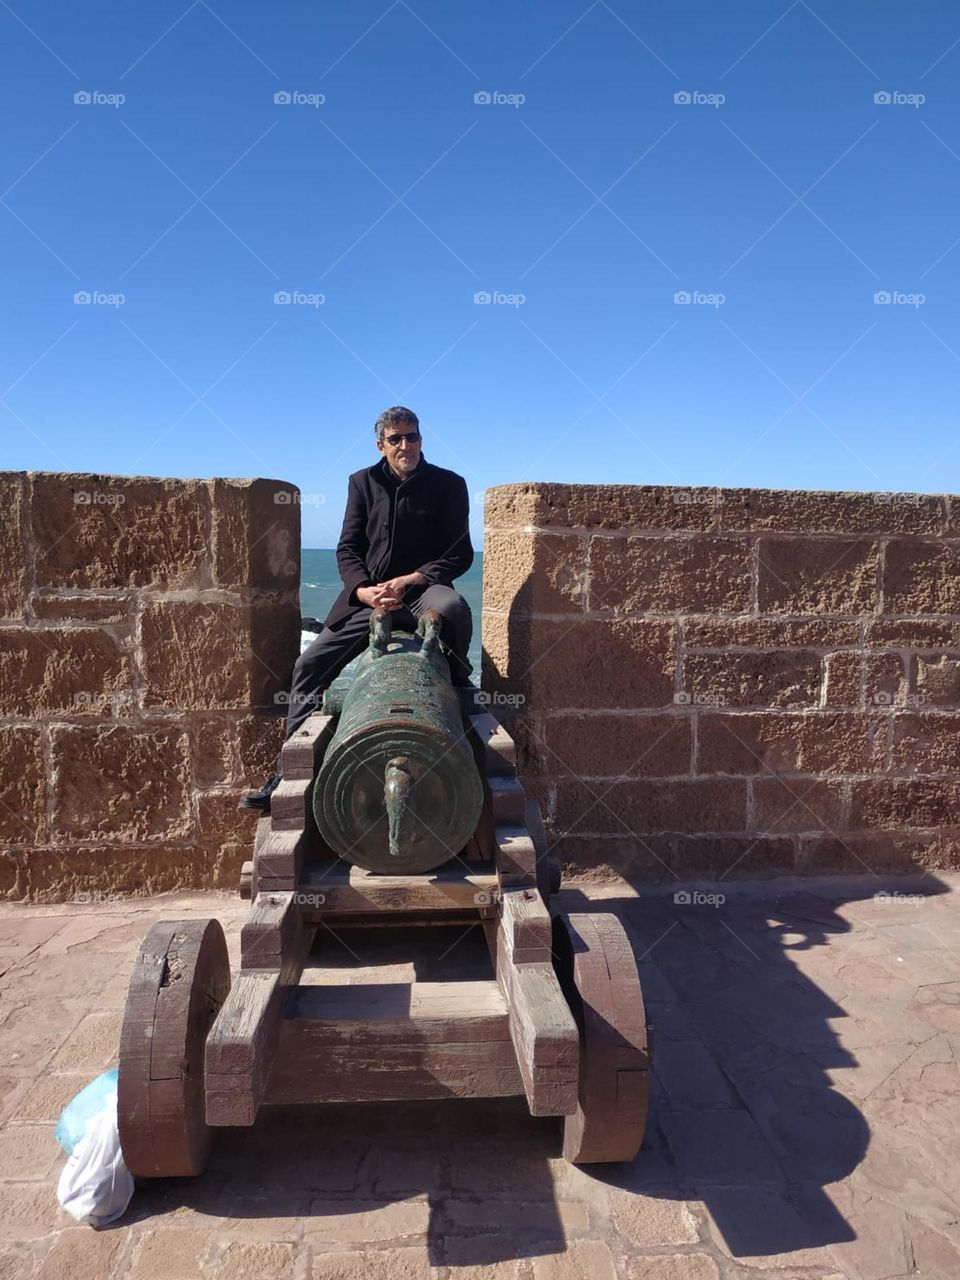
[{"x1": 719, "y1": 489, "x2": 946, "y2": 534}]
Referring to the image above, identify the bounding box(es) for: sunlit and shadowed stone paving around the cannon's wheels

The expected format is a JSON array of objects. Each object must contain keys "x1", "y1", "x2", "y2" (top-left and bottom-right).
[{"x1": 0, "y1": 876, "x2": 960, "y2": 1280}]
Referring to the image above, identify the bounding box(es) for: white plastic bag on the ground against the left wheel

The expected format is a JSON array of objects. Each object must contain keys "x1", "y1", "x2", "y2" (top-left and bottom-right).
[{"x1": 56, "y1": 1091, "x2": 133, "y2": 1226}]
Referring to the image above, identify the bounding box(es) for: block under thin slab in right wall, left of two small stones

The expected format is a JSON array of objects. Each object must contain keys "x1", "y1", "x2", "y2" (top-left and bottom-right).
[{"x1": 682, "y1": 649, "x2": 820, "y2": 708}]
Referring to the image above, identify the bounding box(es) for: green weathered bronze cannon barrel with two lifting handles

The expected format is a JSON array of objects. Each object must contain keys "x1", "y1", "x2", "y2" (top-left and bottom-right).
[{"x1": 314, "y1": 611, "x2": 484, "y2": 874}]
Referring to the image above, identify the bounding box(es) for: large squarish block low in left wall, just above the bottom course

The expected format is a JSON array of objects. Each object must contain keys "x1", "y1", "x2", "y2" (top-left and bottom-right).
[{"x1": 52, "y1": 724, "x2": 191, "y2": 842}]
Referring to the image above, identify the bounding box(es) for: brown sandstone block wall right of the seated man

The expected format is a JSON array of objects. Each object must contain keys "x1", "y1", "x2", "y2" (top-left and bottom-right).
[{"x1": 484, "y1": 484, "x2": 960, "y2": 879}]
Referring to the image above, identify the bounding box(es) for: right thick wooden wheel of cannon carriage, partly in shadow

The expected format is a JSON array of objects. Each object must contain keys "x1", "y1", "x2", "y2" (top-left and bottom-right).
[{"x1": 553, "y1": 914, "x2": 650, "y2": 1165}]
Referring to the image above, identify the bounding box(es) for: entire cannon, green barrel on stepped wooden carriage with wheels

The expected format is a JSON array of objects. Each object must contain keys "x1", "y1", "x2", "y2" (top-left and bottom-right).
[{"x1": 118, "y1": 613, "x2": 649, "y2": 1178}]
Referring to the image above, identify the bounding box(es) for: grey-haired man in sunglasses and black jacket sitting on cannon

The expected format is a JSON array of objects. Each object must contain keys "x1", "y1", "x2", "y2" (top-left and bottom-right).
[{"x1": 241, "y1": 406, "x2": 474, "y2": 812}]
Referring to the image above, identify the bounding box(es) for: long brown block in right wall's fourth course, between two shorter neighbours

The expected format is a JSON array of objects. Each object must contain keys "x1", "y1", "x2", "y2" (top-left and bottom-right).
[{"x1": 695, "y1": 710, "x2": 885, "y2": 773}]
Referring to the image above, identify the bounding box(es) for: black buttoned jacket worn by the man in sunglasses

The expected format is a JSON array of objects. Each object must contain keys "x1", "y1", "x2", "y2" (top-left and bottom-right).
[{"x1": 325, "y1": 454, "x2": 474, "y2": 627}]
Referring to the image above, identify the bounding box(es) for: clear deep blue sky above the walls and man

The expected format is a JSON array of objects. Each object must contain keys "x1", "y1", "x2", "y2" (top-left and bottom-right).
[{"x1": 0, "y1": 0, "x2": 960, "y2": 547}]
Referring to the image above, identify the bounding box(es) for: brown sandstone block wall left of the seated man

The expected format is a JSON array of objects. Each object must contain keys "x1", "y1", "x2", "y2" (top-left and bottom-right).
[{"x1": 0, "y1": 472, "x2": 300, "y2": 900}]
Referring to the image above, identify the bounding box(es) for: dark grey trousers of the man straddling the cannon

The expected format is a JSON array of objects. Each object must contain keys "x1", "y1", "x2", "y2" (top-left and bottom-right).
[{"x1": 287, "y1": 584, "x2": 474, "y2": 737}]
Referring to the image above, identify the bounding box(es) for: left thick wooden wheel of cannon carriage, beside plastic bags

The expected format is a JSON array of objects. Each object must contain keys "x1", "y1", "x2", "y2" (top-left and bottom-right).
[{"x1": 116, "y1": 920, "x2": 230, "y2": 1178}]
